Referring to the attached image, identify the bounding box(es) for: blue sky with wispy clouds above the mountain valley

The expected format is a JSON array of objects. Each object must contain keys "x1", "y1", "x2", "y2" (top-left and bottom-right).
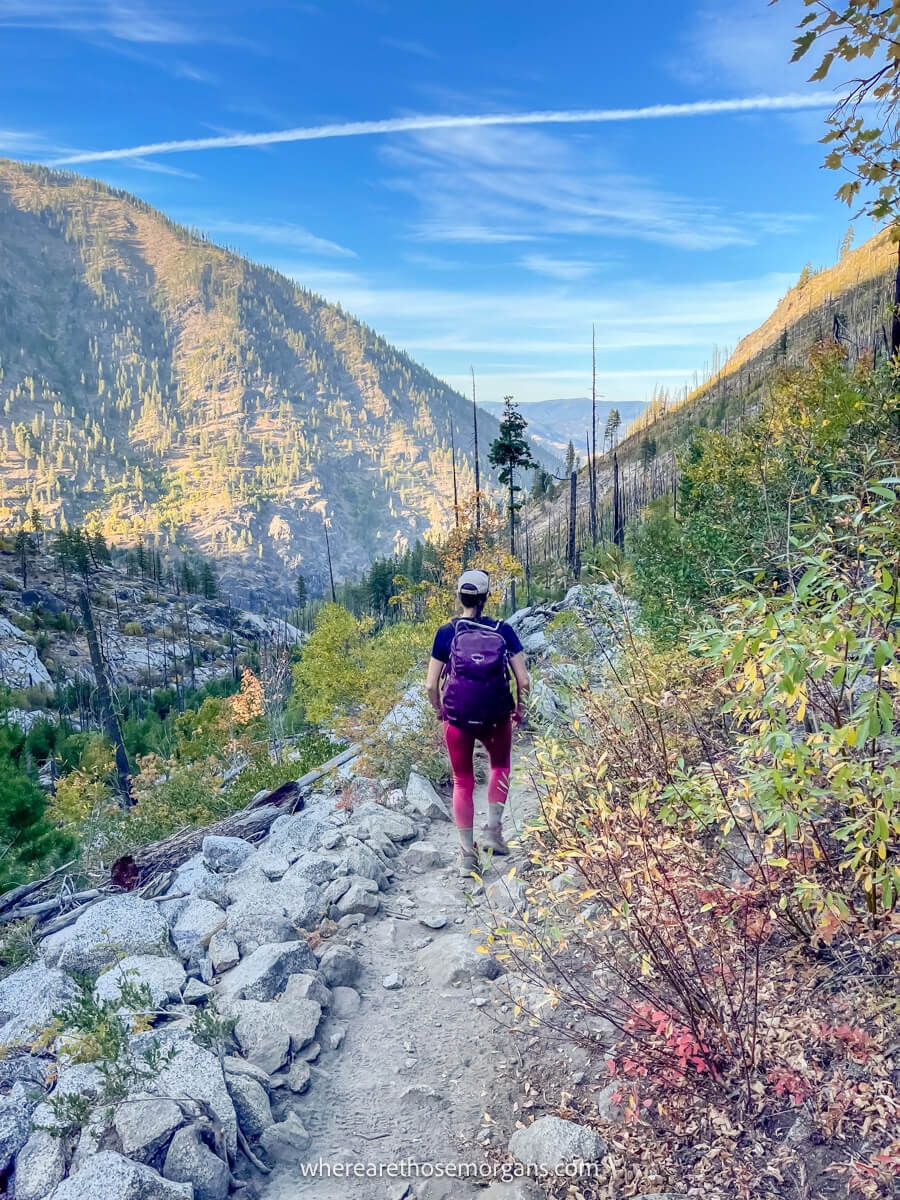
[{"x1": 0, "y1": 0, "x2": 872, "y2": 402}]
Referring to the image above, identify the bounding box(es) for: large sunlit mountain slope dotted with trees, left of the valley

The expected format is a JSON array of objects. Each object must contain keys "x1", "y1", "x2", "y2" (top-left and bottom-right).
[{"x1": 0, "y1": 160, "x2": 508, "y2": 599}]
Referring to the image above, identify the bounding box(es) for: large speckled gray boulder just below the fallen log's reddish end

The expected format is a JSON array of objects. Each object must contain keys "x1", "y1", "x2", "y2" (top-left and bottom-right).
[{"x1": 43, "y1": 893, "x2": 169, "y2": 974}]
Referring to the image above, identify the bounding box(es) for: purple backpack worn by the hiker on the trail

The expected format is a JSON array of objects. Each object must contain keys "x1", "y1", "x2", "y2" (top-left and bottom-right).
[{"x1": 443, "y1": 617, "x2": 515, "y2": 727}]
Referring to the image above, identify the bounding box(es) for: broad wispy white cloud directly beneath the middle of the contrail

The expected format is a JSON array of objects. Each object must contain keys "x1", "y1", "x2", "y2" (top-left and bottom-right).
[{"x1": 383, "y1": 127, "x2": 797, "y2": 252}]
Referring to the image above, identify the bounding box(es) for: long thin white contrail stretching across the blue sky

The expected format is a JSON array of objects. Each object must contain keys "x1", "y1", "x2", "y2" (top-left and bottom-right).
[{"x1": 55, "y1": 91, "x2": 840, "y2": 166}]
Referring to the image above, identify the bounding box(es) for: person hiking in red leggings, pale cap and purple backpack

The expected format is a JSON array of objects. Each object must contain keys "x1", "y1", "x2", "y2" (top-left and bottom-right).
[{"x1": 425, "y1": 571, "x2": 530, "y2": 877}]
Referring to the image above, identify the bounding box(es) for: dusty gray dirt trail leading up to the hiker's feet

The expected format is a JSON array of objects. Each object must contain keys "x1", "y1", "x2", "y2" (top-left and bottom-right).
[{"x1": 260, "y1": 748, "x2": 535, "y2": 1200}]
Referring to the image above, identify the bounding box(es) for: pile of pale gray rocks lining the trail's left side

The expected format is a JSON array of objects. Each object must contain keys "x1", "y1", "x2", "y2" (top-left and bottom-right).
[{"x1": 0, "y1": 775, "x2": 449, "y2": 1200}]
